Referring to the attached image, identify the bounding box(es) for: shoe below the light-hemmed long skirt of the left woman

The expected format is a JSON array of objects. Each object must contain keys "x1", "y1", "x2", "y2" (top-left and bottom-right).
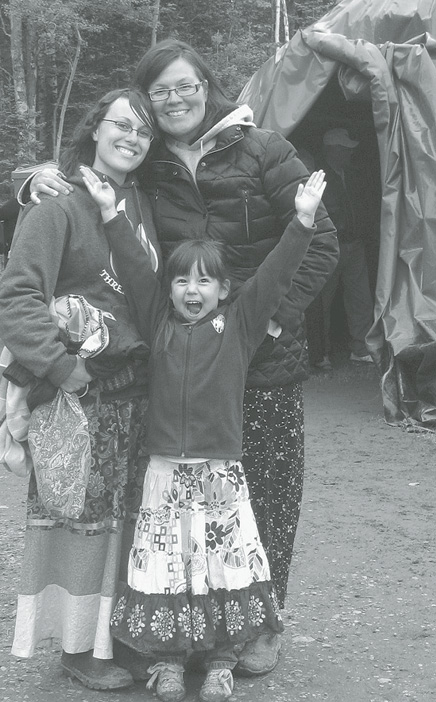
[{"x1": 61, "y1": 651, "x2": 134, "y2": 690}]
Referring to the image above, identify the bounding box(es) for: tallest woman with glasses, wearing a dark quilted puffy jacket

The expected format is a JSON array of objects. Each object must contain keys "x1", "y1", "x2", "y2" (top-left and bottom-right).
[{"x1": 24, "y1": 39, "x2": 338, "y2": 675}]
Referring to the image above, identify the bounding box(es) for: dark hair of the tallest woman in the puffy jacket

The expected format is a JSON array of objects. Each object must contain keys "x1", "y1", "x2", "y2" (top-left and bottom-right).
[{"x1": 133, "y1": 39, "x2": 238, "y2": 139}]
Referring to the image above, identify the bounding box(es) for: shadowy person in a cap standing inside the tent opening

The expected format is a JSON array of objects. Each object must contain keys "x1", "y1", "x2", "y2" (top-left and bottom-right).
[{"x1": 320, "y1": 127, "x2": 374, "y2": 364}]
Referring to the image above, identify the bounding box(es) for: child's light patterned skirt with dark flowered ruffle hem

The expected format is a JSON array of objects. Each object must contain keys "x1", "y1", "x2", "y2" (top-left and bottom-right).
[{"x1": 112, "y1": 456, "x2": 283, "y2": 654}]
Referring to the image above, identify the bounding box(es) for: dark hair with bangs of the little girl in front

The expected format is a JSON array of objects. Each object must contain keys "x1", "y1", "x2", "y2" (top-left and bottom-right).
[{"x1": 165, "y1": 239, "x2": 229, "y2": 286}]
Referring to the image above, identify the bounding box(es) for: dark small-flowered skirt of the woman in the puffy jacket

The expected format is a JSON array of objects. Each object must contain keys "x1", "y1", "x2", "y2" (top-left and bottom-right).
[{"x1": 242, "y1": 383, "x2": 304, "y2": 608}]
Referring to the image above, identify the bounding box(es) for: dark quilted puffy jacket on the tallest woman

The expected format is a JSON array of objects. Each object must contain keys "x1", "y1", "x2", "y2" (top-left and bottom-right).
[{"x1": 143, "y1": 124, "x2": 338, "y2": 389}]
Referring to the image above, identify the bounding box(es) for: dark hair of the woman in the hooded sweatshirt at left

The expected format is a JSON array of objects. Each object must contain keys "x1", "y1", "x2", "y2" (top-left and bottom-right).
[{"x1": 59, "y1": 88, "x2": 157, "y2": 176}]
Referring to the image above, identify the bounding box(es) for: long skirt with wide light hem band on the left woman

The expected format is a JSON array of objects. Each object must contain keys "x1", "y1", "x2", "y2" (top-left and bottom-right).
[{"x1": 12, "y1": 388, "x2": 148, "y2": 658}]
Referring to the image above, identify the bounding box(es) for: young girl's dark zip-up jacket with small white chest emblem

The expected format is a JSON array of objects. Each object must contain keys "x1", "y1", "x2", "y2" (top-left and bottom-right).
[{"x1": 105, "y1": 209, "x2": 316, "y2": 460}]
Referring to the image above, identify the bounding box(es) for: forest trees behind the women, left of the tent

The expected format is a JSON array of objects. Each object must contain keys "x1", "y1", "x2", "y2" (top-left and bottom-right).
[{"x1": 0, "y1": 0, "x2": 337, "y2": 202}]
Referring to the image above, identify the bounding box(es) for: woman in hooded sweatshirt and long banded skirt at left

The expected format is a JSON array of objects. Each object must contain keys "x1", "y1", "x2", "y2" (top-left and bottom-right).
[{"x1": 0, "y1": 90, "x2": 159, "y2": 690}]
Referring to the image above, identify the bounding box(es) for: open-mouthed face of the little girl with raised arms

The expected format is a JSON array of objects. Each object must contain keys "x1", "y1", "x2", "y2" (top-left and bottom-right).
[{"x1": 170, "y1": 263, "x2": 230, "y2": 323}]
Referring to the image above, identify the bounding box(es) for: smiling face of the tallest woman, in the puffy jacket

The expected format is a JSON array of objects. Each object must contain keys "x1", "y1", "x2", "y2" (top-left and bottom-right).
[{"x1": 148, "y1": 58, "x2": 207, "y2": 142}]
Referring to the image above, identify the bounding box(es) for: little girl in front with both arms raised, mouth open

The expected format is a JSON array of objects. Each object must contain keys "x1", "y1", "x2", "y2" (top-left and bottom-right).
[{"x1": 84, "y1": 166, "x2": 325, "y2": 702}]
